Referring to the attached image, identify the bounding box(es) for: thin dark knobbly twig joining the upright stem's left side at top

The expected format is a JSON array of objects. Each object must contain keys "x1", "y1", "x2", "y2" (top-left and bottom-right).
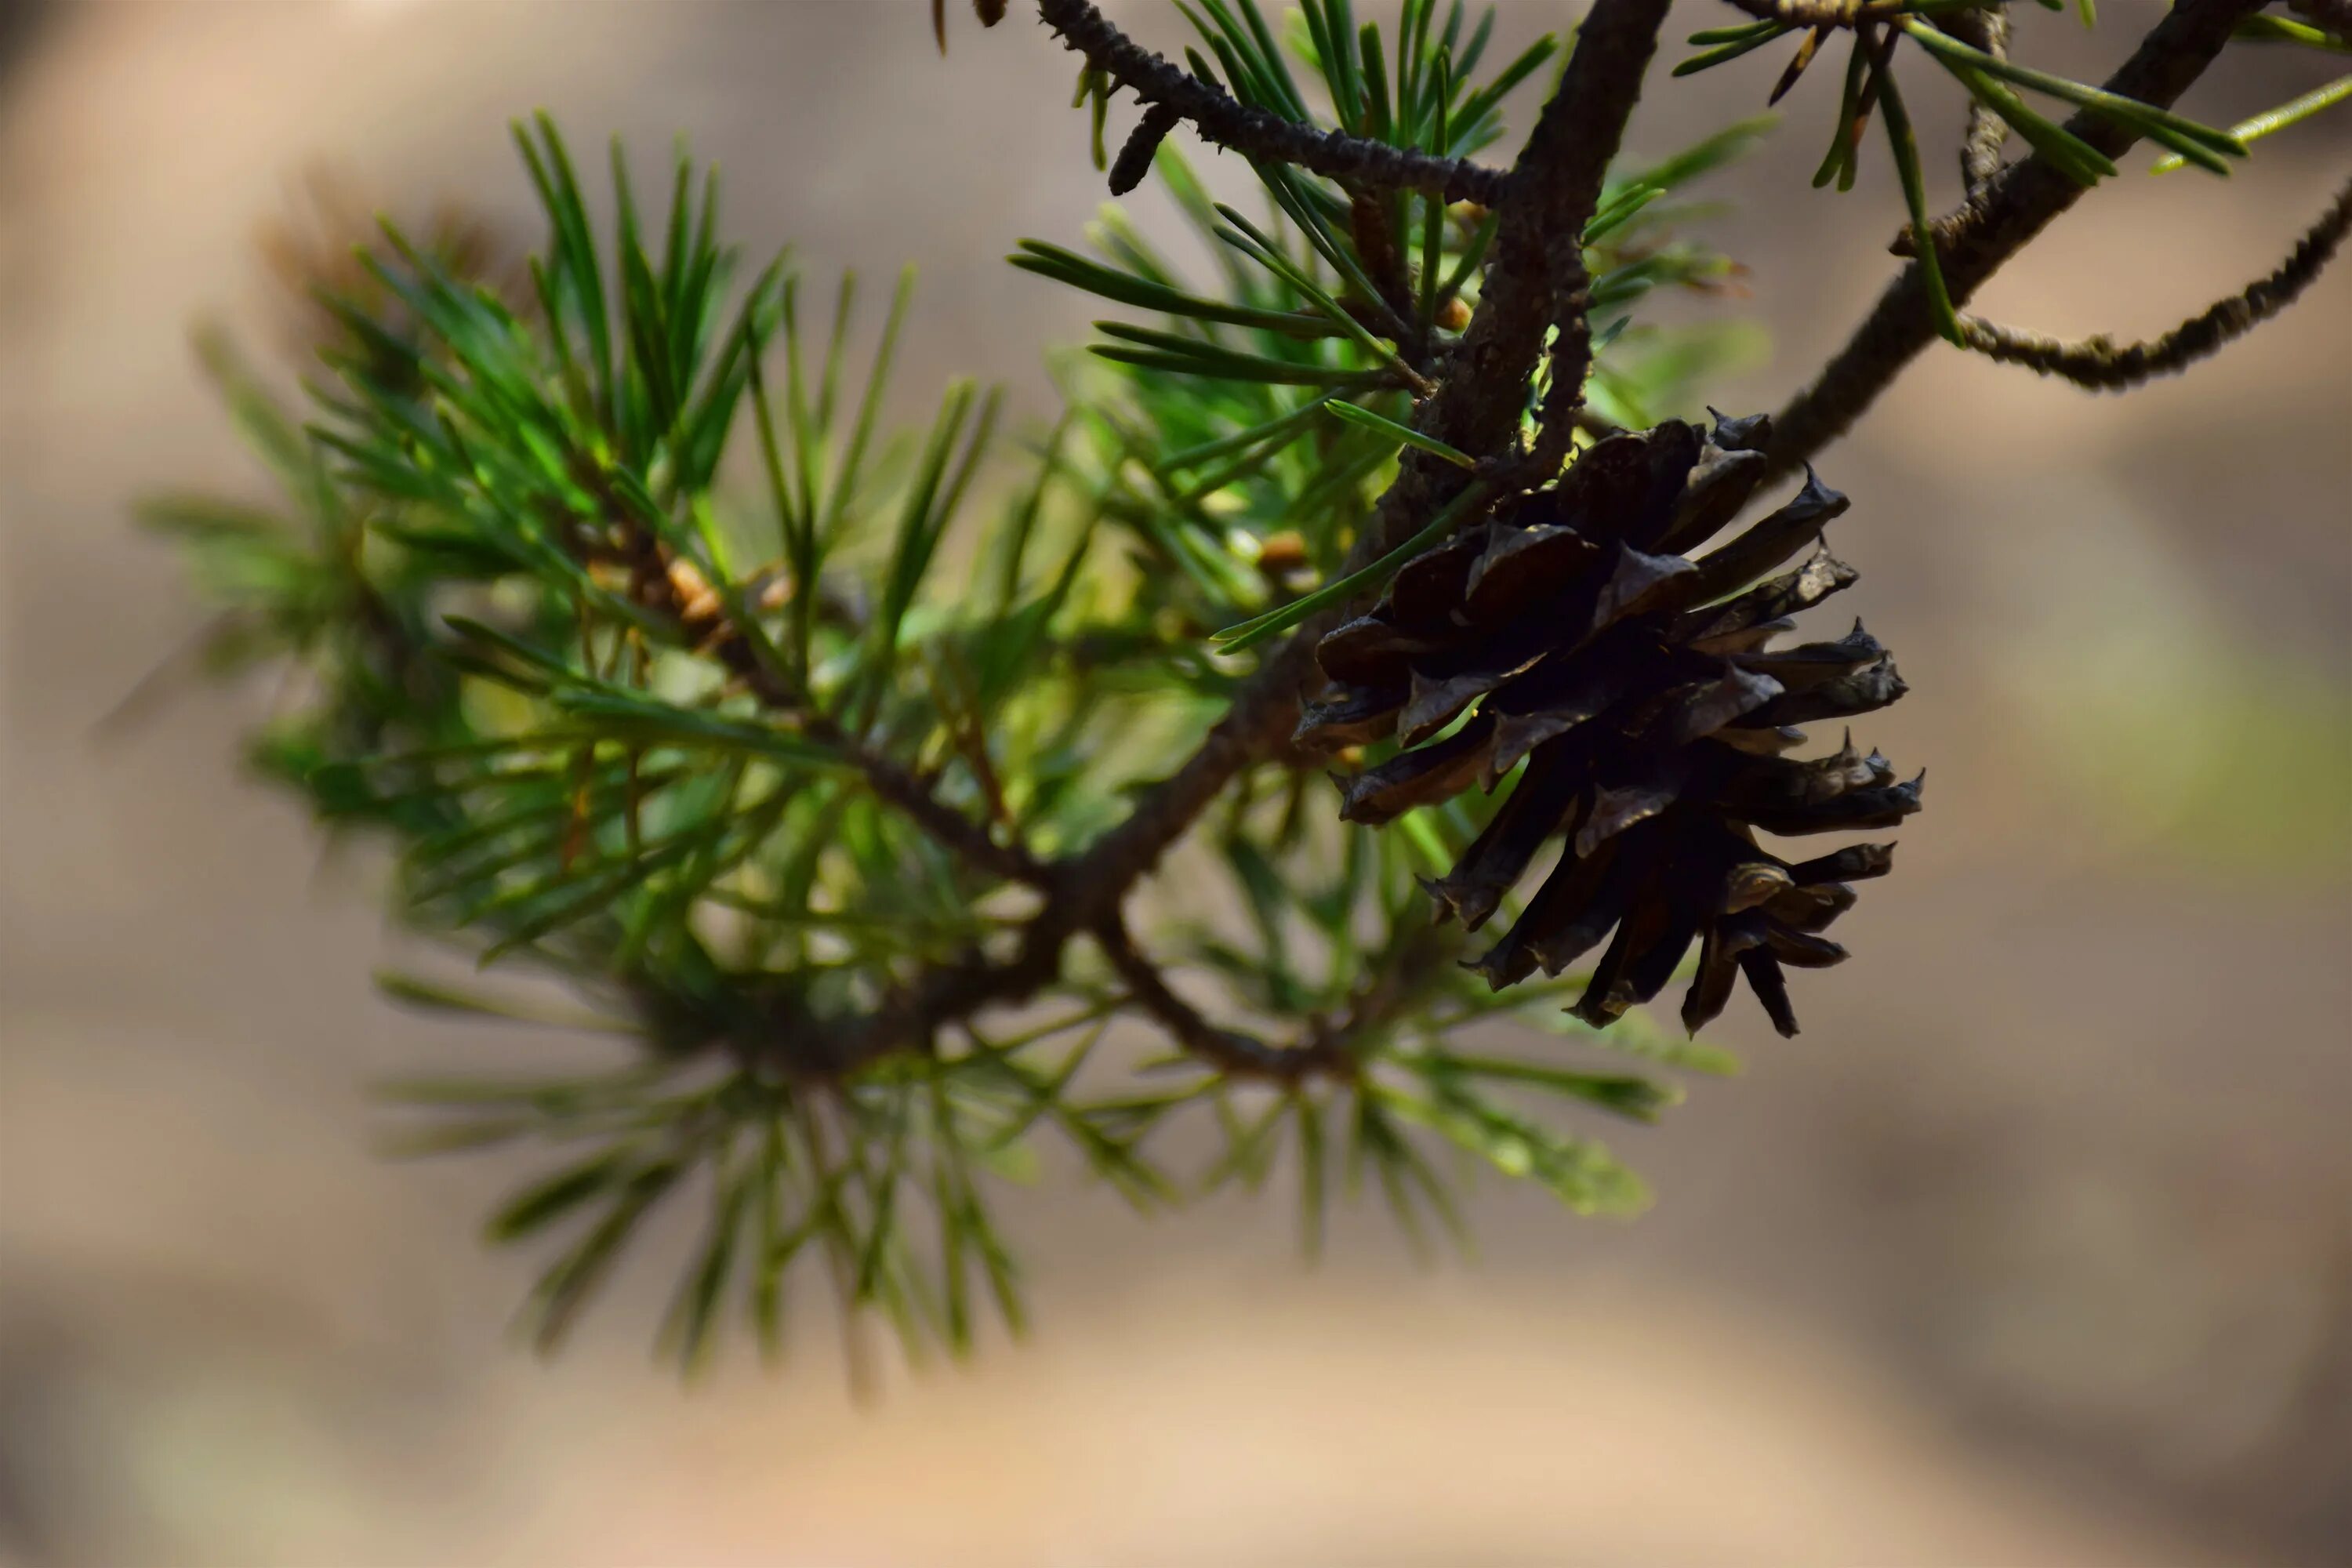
[{"x1": 1037, "y1": 0, "x2": 1505, "y2": 207}]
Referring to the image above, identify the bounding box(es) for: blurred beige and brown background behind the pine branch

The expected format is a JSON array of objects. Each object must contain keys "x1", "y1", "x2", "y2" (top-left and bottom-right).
[{"x1": 0, "y1": 0, "x2": 2352, "y2": 1568}]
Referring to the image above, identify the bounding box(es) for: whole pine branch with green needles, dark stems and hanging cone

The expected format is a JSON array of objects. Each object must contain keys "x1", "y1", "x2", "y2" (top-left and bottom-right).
[{"x1": 151, "y1": 0, "x2": 2314, "y2": 1368}]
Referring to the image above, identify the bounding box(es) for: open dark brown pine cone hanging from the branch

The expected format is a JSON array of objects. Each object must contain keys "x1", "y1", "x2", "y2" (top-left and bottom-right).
[{"x1": 1296, "y1": 416, "x2": 1926, "y2": 1034}]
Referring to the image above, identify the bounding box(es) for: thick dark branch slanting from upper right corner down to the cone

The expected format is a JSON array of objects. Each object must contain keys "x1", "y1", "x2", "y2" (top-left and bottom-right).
[{"x1": 1766, "y1": 0, "x2": 2263, "y2": 482}]
